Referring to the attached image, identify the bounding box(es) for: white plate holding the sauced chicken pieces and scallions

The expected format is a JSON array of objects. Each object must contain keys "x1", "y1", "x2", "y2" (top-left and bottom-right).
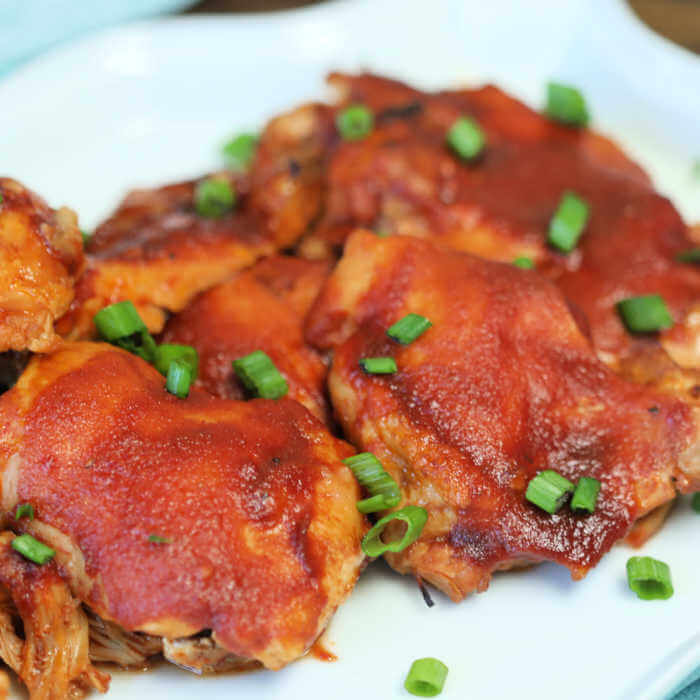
[{"x1": 0, "y1": 0, "x2": 700, "y2": 700}]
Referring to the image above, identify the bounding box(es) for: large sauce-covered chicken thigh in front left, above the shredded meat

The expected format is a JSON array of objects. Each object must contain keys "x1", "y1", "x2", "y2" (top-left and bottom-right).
[{"x1": 0, "y1": 343, "x2": 365, "y2": 669}]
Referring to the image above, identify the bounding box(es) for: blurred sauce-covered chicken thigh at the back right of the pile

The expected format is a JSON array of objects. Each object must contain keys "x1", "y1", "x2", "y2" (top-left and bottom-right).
[{"x1": 276, "y1": 74, "x2": 700, "y2": 386}]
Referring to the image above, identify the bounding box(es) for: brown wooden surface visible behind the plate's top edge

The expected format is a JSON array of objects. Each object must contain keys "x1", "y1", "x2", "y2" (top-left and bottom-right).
[{"x1": 191, "y1": 0, "x2": 700, "y2": 53}]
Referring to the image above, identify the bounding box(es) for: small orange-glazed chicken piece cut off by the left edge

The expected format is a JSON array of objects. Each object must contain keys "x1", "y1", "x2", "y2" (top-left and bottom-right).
[{"x1": 0, "y1": 177, "x2": 83, "y2": 352}]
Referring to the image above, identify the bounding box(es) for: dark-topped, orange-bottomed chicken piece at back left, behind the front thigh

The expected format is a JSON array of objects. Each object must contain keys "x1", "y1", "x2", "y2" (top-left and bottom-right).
[{"x1": 60, "y1": 173, "x2": 280, "y2": 340}]
